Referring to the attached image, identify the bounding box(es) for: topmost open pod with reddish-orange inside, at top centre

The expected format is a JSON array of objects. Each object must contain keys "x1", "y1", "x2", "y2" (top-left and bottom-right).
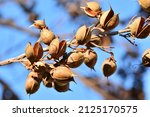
[{"x1": 81, "y1": 2, "x2": 101, "y2": 18}]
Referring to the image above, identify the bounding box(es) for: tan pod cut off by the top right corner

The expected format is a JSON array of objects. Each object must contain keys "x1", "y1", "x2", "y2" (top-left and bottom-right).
[{"x1": 138, "y1": 0, "x2": 150, "y2": 12}]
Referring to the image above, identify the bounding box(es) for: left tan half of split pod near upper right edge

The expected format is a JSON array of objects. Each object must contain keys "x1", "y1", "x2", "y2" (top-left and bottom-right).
[{"x1": 129, "y1": 17, "x2": 145, "y2": 36}]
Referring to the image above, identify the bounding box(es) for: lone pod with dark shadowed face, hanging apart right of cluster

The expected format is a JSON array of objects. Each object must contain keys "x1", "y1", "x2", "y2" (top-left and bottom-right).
[{"x1": 102, "y1": 57, "x2": 117, "y2": 78}]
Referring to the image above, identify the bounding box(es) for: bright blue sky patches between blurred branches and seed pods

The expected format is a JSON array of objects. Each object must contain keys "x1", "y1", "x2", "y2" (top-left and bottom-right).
[{"x1": 0, "y1": 0, "x2": 150, "y2": 100}]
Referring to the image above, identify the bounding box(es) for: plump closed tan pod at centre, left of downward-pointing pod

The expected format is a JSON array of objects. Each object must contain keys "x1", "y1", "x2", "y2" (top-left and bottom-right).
[{"x1": 67, "y1": 52, "x2": 84, "y2": 68}]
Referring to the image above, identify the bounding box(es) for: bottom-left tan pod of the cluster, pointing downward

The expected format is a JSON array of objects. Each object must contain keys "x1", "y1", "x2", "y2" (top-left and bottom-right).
[{"x1": 25, "y1": 72, "x2": 41, "y2": 94}]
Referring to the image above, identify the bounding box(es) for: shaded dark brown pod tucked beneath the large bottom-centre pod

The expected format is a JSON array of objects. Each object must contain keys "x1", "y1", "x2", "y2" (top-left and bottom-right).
[{"x1": 54, "y1": 82, "x2": 70, "y2": 92}]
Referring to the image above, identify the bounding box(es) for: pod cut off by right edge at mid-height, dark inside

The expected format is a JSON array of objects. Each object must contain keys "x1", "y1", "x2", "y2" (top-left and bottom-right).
[{"x1": 142, "y1": 49, "x2": 150, "y2": 67}]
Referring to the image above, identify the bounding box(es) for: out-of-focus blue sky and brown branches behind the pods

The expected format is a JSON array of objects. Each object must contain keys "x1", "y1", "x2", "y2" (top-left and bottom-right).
[{"x1": 0, "y1": 0, "x2": 150, "y2": 100}]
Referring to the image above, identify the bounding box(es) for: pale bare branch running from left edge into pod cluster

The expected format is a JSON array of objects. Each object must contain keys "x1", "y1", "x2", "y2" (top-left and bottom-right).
[{"x1": 0, "y1": 48, "x2": 48, "y2": 66}]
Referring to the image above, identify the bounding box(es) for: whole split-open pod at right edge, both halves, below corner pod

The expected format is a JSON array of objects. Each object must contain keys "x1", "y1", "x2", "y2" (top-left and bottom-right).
[{"x1": 128, "y1": 17, "x2": 150, "y2": 39}]
